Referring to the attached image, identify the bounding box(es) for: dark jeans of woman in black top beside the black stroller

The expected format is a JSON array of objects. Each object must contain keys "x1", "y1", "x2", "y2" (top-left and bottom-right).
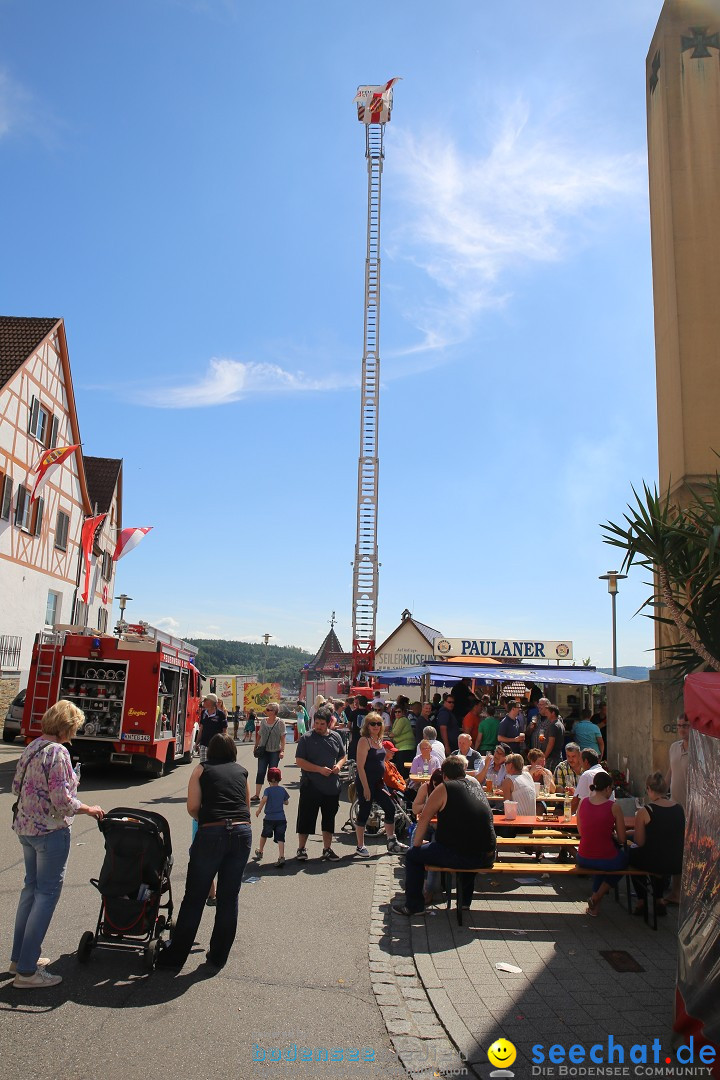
[{"x1": 159, "y1": 825, "x2": 253, "y2": 968}]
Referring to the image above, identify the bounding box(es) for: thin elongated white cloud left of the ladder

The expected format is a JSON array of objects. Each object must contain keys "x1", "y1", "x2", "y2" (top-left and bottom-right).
[{"x1": 134, "y1": 356, "x2": 358, "y2": 408}]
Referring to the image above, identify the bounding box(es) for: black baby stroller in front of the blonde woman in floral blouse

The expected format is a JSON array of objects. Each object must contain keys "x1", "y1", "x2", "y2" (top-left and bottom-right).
[{"x1": 78, "y1": 807, "x2": 173, "y2": 971}]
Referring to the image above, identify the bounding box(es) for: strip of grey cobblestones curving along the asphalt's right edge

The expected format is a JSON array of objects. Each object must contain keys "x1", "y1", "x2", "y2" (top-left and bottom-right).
[{"x1": 368, "y1": 859, "x2": 480, "y2": 1080}]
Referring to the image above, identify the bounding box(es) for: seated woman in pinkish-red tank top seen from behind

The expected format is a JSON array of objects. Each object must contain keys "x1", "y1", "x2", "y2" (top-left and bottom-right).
[{"x1": 578, "y1": 772, "x2": 627, "y2": 916}]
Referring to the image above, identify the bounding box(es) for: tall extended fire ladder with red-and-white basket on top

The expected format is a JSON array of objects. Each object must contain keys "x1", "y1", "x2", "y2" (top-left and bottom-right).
[{"x1": 352, "y1": 79, "x2": 396, "y2": 680}]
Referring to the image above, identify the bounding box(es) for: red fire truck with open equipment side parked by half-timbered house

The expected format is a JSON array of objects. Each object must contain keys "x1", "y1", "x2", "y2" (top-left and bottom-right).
[{"x1": 21, "y1": 623, "x2": 201, "y2": 777}]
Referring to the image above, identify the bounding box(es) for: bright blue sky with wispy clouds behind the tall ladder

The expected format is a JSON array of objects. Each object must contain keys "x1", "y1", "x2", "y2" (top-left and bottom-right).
[{"x1": 0, "y1": 0, "x2": 661, "y2": 665}]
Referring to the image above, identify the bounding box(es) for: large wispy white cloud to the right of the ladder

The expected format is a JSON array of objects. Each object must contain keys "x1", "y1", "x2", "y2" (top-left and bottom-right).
[{"x1": 390, "y1": 103, "x2": 644, "y2": 349}]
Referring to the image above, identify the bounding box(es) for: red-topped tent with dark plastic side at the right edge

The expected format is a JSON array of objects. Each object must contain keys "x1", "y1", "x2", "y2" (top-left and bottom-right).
[{"x1": 675, "y1": 672, "x2": 720, "y2": 1078}]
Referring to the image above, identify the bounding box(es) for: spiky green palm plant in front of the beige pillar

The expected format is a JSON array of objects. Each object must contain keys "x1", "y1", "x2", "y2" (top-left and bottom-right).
[{"x1": 601, "y1": 475, "x2": 720, "y2": 679}]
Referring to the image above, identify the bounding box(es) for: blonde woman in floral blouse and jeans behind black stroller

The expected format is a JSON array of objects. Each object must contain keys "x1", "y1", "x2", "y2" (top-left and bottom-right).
[{"x1": 10, "y1": 701, "x2": 103, "y2": 989}]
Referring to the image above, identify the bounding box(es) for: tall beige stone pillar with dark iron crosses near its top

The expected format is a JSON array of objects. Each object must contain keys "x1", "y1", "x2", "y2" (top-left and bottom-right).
[{"x1": 647, "y1": 0, "x2": 720, "y2": 501}]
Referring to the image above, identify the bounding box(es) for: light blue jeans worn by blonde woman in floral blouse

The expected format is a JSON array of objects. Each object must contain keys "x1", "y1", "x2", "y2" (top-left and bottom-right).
[{"x1": 10, "y1": 827, "x2": 70, "y2": 975}]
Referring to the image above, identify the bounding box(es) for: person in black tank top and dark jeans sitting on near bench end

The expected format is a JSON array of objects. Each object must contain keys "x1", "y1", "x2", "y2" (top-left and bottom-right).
[{"x1": 392, "y1": 757, "x2": 495, "y2": 915}]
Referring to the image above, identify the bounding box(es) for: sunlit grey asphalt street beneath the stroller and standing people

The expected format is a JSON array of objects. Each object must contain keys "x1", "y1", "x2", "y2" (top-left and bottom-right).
[{"x1": 0, "y1": 744, "x2": 407, "y2": 1080}]
